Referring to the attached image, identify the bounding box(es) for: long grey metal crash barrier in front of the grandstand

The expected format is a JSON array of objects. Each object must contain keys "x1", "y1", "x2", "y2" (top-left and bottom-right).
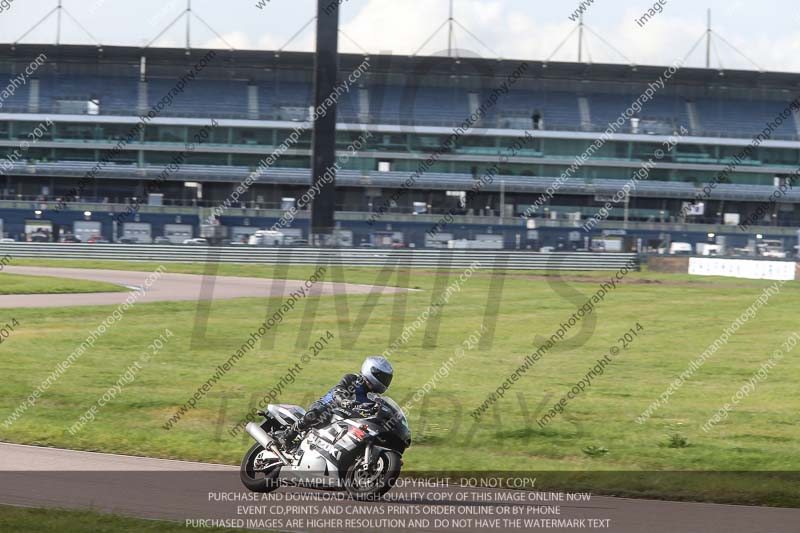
[{"x1": 0, "y1": 243, "x2": 639, "y2": 270}]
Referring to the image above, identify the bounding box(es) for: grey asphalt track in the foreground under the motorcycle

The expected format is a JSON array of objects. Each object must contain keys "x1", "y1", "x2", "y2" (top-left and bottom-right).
[{"x1": 0, "y1": 444, "x2": 800, "y2": 533}]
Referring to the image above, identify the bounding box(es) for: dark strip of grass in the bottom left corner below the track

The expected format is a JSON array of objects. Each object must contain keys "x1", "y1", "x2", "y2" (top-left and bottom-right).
[{"x1": 0, "y1": 505, "x2": 266, "y2": 533}]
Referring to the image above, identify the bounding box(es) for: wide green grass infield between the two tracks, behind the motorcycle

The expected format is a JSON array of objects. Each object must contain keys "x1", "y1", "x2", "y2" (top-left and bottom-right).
[{"x1": 0, "y1": 261, "x2": 800, "y2": 505}]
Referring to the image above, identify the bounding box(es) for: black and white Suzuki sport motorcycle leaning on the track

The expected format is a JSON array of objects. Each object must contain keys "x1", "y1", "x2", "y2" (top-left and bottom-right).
[{"x1": 239, "y1": 393, "x2": 411, "y2": 500}]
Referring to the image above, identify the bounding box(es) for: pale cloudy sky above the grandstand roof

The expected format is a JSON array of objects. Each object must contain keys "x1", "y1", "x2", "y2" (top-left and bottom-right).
[{"x1": 0, "y1": 0, "x2": 800, "y2": 72}]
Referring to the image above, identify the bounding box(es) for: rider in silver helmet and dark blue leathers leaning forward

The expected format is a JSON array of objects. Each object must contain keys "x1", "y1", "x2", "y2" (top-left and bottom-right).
[{"x1": 278, "y1": 356, "x2": 394, "y2": 450}]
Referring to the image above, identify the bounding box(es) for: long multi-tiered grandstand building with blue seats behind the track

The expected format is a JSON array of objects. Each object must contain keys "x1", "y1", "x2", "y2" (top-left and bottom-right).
[{"x1": 0, "y1": 45, "x2": 800, "y2": 253}]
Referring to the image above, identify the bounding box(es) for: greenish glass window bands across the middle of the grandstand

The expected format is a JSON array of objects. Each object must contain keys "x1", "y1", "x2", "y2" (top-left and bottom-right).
[{"x1": 0, "y1": 121, "x2": 800, "y2": 192}]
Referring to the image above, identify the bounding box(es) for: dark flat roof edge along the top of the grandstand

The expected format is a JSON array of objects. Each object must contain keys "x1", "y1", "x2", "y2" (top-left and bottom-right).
[{"x1": 0, "y1": 44, "x2": 800, "y2": 91}]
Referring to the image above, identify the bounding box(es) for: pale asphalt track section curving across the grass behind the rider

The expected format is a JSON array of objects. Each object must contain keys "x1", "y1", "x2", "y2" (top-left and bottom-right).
[{"x1": 0, "y1": 266, "x2": 402, "y2": 309}]
